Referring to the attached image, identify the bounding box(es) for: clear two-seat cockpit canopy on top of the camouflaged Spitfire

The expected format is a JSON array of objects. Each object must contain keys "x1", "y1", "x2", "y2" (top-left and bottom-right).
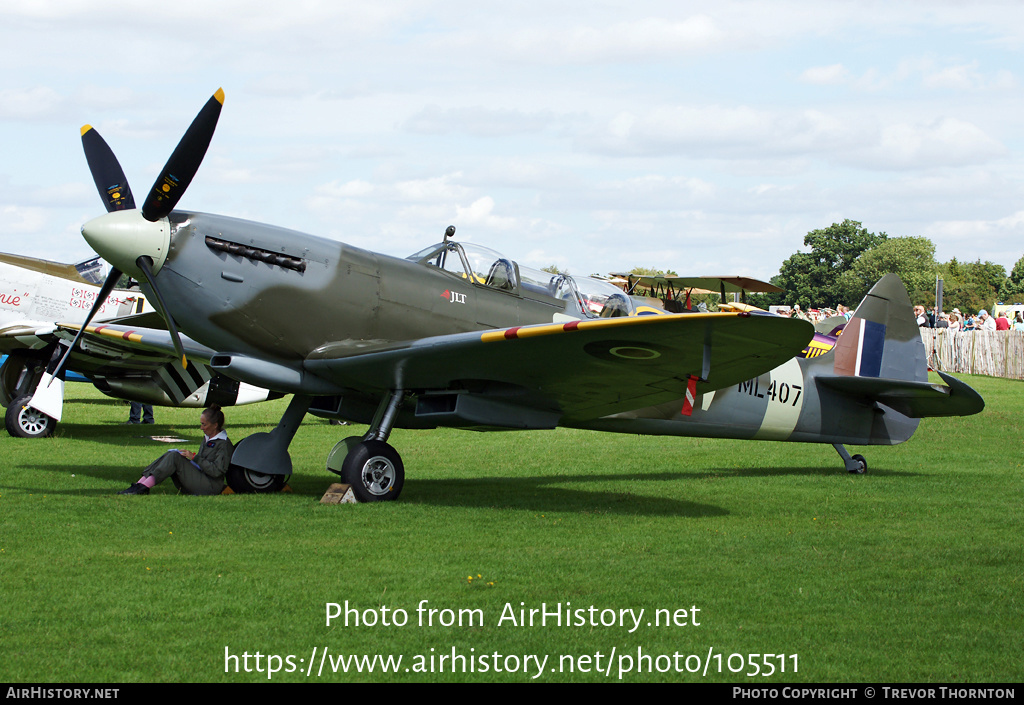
[{"x1": 407, "y1": 240, "x2": 633, "y2": 318}]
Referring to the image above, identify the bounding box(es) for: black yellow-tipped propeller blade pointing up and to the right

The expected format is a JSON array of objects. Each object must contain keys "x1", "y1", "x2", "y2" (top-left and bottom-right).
[{"x1": 142, "y1": 88, "x2": 224, "y2": 221}]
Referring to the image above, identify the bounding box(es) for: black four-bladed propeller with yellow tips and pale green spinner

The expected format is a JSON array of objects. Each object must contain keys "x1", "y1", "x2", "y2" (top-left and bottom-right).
[{"x1": 52, "y1": 88, "x2": 224, "y2": 378}]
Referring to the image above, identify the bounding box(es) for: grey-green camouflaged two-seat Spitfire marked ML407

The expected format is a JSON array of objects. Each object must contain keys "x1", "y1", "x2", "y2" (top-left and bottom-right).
[{"x1": 53, "y1": 90, "x2": 984, "y2": 501}]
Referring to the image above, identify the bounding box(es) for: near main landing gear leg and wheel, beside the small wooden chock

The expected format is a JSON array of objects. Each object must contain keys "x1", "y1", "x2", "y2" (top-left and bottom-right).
[{"x1": 327, "y1": 389, "x2": 406, "y2": 502}]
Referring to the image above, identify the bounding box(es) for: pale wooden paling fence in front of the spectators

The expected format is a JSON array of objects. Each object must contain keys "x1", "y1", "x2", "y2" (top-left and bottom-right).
[{"x1": 921, "y1": 328, "x2": 1024, "y2": 379}]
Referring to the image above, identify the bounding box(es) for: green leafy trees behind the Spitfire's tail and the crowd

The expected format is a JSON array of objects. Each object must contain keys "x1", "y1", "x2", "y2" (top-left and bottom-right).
[{"x1": 748, "y1": 219, "x2": 1024, "y2": 312}]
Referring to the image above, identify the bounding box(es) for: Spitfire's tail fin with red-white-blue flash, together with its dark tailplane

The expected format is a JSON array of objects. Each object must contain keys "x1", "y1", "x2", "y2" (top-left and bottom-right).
[{"x1": 816, "y1": 274, "x2": 985, "y2": 418}]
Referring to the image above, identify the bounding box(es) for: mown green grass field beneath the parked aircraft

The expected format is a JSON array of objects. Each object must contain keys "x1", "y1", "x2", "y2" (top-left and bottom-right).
[{"x1": 0, "y1": 377, "x2": 1024, "y2": 685}]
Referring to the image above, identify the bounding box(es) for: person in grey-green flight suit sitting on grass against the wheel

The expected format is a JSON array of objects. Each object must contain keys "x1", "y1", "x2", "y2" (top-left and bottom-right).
[{"x1": 118, "y1": 404, "x2": 234, "y2": 495}]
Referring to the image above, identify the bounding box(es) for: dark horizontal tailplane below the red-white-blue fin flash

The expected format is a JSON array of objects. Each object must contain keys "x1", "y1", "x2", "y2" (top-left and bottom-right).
[{"x1": 816, "y1": 372, "x2": 985, "y2": 418}]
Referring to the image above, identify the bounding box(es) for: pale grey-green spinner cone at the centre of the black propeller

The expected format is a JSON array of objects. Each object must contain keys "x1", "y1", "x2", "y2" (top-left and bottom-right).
[{"x1": 82, "y1": 210, "x2": 171, "y2": 279}]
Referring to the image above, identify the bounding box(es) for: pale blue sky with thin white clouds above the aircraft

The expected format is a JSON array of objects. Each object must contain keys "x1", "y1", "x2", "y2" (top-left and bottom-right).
[{"x1": 0, "y1": 0, "x2": 1024, "y2": 280}]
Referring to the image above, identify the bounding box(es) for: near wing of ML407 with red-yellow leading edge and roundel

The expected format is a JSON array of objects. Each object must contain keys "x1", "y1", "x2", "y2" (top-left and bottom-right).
[{"x1": 299, "y1": 313, "x2": 814, "y2": 425}]
